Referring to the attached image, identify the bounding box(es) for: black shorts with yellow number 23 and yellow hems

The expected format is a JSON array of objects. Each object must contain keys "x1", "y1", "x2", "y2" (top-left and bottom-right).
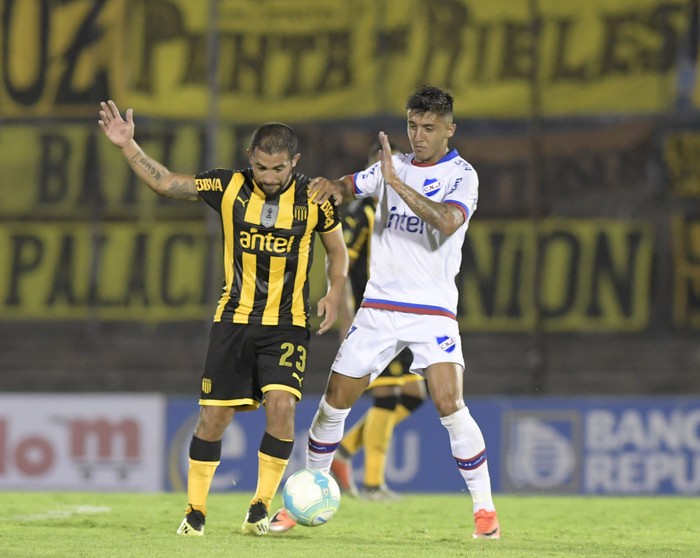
[{"x1": 199, "y1": 322, "x2": 309, "y2": 411}]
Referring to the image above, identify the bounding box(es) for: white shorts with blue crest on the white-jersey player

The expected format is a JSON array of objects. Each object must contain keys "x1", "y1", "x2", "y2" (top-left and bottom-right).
[{"x1": 331, "y1": 308, "x2": 464, "y2": 381}]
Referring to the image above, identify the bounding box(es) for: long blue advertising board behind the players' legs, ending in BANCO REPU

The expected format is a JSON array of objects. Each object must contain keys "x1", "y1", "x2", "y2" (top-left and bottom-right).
[{"x1": 164, "y1": 396, "x2": 700, "y2": 495}]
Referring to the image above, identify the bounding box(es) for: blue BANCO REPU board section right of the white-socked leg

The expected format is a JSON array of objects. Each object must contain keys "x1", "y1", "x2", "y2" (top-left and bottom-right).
[{"x1": 491, "y1": 397, "x2": 700, "y2": 495}]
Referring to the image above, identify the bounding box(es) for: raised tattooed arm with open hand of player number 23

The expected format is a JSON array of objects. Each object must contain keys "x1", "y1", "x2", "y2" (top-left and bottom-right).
[{"x1": 98, "y1": 101, "x2": 199, "y2": 201}]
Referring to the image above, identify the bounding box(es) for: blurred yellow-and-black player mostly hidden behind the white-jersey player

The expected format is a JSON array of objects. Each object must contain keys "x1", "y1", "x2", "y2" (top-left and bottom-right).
[{"x1": 331, "y1": 141, "x2": 426, "y2": 502}]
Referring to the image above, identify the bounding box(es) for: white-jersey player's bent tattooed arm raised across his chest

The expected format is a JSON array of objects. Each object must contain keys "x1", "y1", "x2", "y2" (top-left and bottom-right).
[{"x1": 379, "y1": 132, "x2": 467, "y2": 236}]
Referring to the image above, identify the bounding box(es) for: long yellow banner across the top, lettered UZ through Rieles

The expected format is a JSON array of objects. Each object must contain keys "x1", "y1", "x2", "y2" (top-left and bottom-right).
[{"x1": 0, "y1": 0, "x2": 693, "y2": 123}]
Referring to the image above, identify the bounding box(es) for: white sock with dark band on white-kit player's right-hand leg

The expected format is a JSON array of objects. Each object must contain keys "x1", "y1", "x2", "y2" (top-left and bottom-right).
[{"x1": 440, "y1": 407, "x2": 496, "y2": 512}]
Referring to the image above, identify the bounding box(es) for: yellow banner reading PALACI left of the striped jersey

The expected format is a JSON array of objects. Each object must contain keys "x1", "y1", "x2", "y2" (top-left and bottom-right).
[{"x1": 0, "y1": 222, "x2": 215, "y2": 322}]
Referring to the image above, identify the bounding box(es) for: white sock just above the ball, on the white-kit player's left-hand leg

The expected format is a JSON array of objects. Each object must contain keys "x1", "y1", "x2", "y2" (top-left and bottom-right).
[{"x1": 306, "y1": 397, "x2": 350, "y2": 471}]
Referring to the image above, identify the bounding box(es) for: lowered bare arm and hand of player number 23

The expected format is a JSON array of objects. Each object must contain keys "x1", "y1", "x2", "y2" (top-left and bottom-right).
[{"x1": 316, "y1": 225, "x2": 348, "y2": 335}]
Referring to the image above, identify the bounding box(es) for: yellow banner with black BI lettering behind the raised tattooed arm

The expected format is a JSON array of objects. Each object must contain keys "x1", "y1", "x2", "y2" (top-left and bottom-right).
[{"x1": 0, "y1": 119, "x2": 238, "y2": 220}]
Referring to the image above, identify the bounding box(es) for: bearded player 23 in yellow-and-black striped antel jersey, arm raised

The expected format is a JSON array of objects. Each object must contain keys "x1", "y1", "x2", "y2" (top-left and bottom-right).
[{"x1": 99, "y1": 101, "x2": 348, "y2": 536}]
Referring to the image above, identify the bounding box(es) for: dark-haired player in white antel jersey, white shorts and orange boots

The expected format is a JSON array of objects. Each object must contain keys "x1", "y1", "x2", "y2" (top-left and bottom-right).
[{"x1": 270, "y1": 86, "x2": 500, "y2": 539}]
